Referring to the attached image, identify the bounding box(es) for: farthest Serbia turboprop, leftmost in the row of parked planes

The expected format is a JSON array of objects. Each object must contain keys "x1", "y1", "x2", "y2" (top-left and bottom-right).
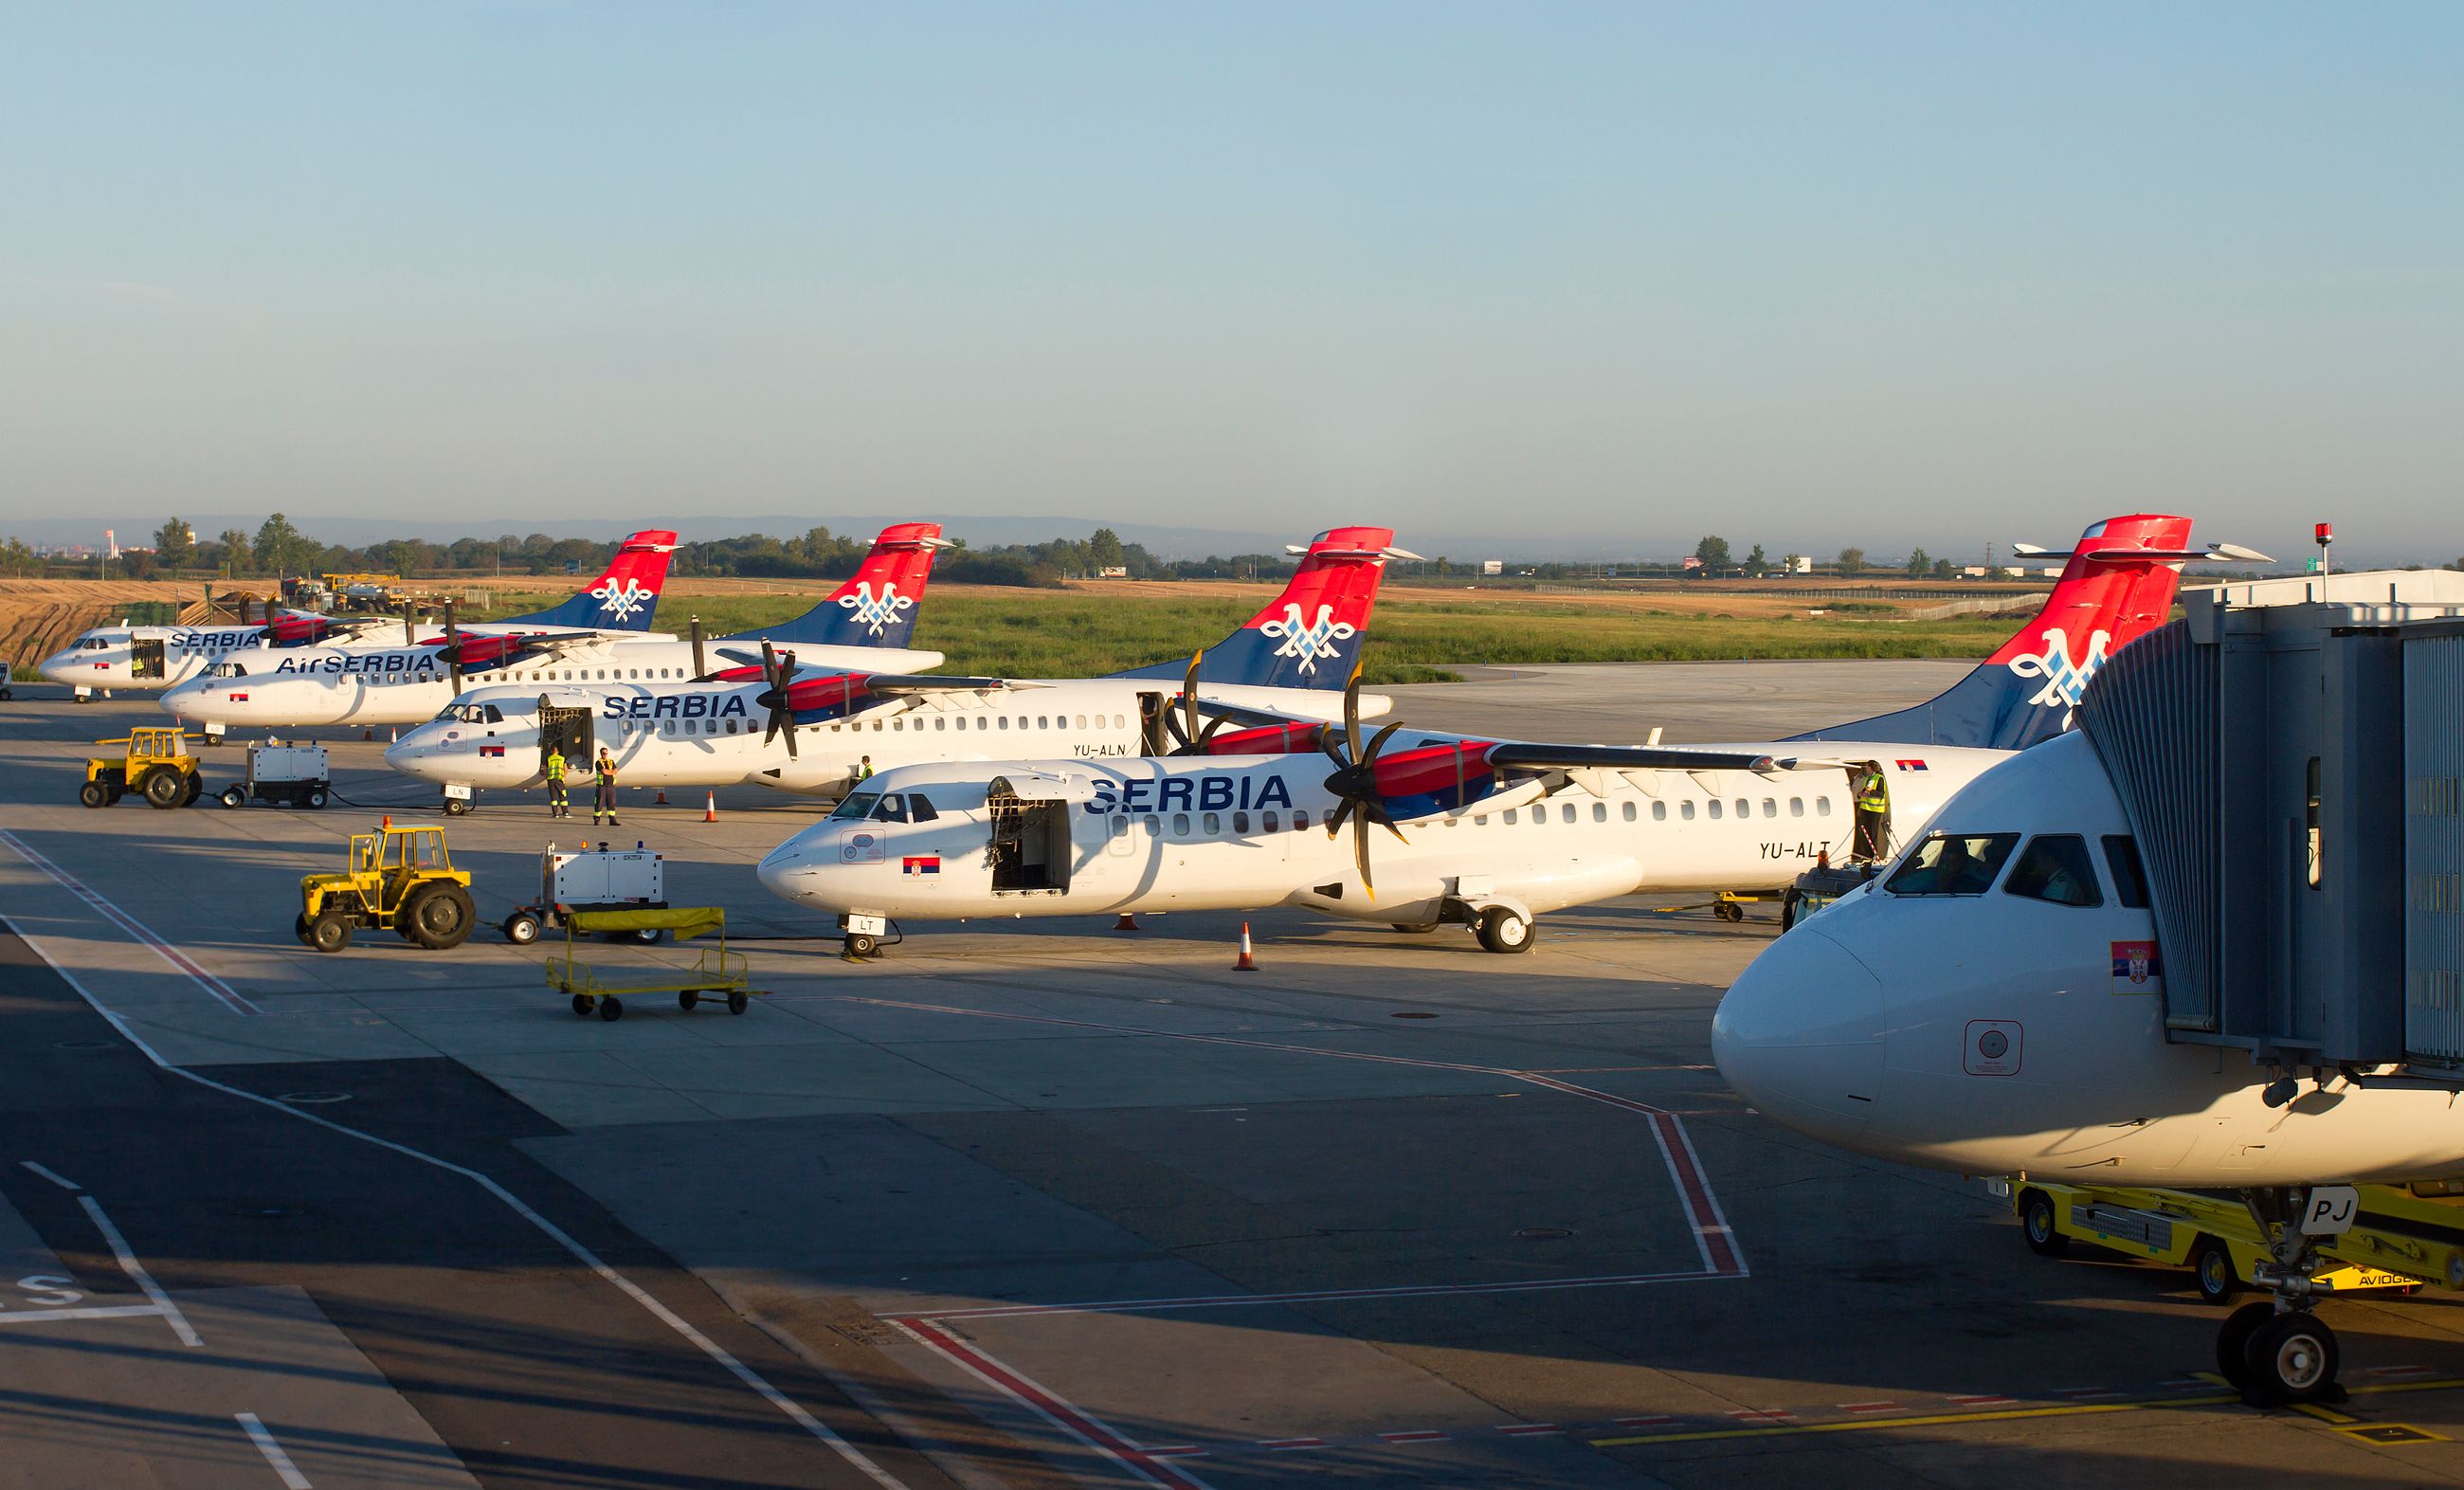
[{"x1": 42, "y1": 532, "x2": 675, "y2": 699}]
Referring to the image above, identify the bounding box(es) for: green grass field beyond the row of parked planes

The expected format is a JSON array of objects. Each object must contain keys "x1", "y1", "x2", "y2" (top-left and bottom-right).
[{"x1": 471, "y1": 584, "x2": 2018, "y2": 684}]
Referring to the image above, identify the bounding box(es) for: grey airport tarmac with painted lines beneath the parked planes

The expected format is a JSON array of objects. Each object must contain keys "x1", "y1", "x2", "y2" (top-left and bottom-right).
[{"x1": 0, "y1": 663, "x2": 2464, "y2": 1490}]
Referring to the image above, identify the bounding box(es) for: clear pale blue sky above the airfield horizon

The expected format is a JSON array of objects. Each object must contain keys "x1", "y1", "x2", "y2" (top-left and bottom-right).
[{"x1": 0, "y1": 3, "x2": 2464, "y2": 556}]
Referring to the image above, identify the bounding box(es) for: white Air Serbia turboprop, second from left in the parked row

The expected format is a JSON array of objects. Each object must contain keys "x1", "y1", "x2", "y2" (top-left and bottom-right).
[{"x1": 163, "y1": 522, "x2": 949, "y2": 729}]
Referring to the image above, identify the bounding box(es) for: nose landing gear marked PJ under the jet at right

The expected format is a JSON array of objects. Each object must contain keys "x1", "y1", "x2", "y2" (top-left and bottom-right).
[{"x1": 2215, "y1": 1187, "x2": 2356, "y2": 1407}]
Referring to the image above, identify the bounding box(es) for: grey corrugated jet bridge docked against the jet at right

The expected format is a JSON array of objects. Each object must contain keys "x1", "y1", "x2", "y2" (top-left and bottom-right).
[{"x1": 2077, "y1": 572, "x2": 2464, "y2": 1086}]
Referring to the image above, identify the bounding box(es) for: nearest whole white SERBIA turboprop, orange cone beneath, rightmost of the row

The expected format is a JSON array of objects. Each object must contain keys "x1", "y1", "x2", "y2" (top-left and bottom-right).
[{"x1": 761, "y1": 518, "x2": 2247, "y2": 954}]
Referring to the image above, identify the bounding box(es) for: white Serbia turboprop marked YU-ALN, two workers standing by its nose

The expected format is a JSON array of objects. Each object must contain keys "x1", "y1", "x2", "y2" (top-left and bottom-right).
[{"x1": 385, "y1": 527, "x2": 1417, "y2": 798}]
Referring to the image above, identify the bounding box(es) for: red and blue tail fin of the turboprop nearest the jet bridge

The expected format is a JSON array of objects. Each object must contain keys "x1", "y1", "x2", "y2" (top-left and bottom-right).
[{"x1": 1794, "y1": 512, "x2": 2208, "y2": 751}]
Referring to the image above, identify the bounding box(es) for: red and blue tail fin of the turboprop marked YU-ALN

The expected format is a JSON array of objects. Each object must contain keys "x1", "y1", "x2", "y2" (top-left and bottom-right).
[{"x1": 1114, "y1": 527, "x2": 1420, "y2": 690}]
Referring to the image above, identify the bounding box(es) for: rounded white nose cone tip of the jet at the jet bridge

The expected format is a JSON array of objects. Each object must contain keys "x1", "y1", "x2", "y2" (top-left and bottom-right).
[{"x1": 1710, "y1": 926, "x2": 1888, "y2": 1140}]
